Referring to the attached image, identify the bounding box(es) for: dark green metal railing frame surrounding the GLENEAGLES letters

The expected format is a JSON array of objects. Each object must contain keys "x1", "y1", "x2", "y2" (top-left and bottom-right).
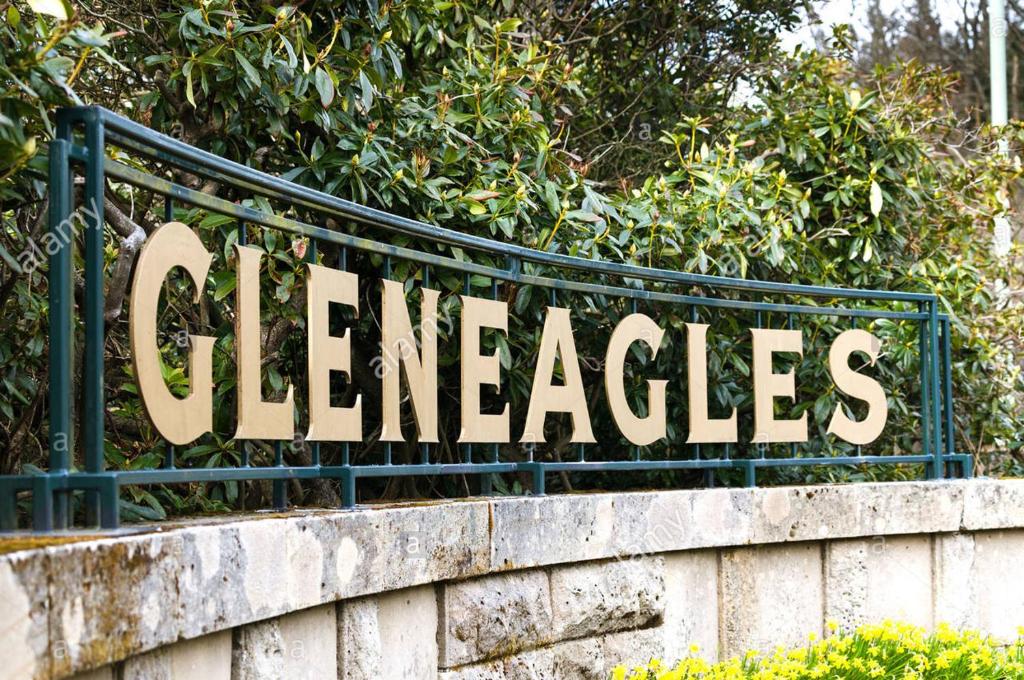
[{"x1": 0, "y1": 107, "x2": 971, "y2": 530}]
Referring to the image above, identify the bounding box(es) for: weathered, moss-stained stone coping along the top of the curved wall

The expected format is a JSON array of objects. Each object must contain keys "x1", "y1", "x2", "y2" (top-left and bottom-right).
[{"x1": 0, "y1": 479, "x2": 1024, "y2": 678}]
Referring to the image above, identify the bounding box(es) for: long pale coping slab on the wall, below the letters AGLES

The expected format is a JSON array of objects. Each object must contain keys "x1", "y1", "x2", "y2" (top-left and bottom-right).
[{"x1": 490, "y1": 481, "x2": 962, "y2": 569}]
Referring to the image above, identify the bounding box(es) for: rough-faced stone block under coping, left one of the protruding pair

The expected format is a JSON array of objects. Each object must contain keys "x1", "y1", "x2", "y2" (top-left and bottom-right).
[{"x1": 438, "y1": 569, "x2": 552, "y2": 668}]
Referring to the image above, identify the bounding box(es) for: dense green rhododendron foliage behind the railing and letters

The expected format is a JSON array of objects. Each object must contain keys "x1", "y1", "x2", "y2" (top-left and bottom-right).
[{"x1": 0, "y1": 0, "x2": 1024, "y2": 516}]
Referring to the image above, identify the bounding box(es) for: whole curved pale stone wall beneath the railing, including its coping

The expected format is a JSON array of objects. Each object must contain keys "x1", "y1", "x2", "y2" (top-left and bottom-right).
[{"x1": 0, "y1": 480, "x2": 1024, "y2": 680}]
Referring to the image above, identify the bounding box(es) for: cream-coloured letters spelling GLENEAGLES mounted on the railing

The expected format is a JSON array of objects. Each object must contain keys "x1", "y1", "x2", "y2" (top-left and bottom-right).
[{"x1": 130, "y1": 222, "x2": 888, "y2": 445}]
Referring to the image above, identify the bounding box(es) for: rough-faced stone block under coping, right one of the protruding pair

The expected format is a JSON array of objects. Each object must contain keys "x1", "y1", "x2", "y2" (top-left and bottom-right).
[{"x1": 550, "y1": 557, "x2": 665, "y2": 640}]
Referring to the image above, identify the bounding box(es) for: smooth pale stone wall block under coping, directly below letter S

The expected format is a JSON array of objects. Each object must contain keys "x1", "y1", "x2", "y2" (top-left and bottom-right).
[{"x1": 825, "y1": 536, "x2": 934, "y2": 630}]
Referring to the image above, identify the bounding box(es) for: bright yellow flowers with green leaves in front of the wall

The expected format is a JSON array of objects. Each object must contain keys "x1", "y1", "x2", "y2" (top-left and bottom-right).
[{"x1": 611, "y1": 622, "x2": 1024, "y2": 680}]
